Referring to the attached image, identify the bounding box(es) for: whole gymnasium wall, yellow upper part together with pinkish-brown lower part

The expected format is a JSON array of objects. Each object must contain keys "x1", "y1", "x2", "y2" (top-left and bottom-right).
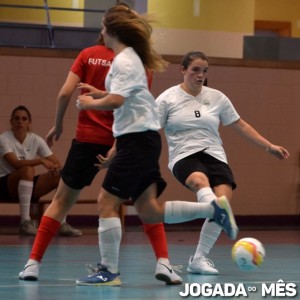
[{"x1": 0, "y1": 0, "x2": 300, "y2": 220}]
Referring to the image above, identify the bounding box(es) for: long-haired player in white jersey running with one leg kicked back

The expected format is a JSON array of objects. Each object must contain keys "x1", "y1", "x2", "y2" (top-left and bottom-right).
[{"x1": 77, "y1": 5, "x2": 237, "y2": 286}]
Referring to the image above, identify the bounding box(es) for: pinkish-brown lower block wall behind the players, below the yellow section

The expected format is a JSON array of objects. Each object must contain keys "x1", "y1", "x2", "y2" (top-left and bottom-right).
[{"x1": 0, "y1": 48, "x2": 300, "y2": 216}]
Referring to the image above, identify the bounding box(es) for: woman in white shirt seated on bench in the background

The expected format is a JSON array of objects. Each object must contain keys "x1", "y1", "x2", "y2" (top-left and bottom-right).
[{"x1": 0, "y1": 106, "x2": 82, "y2": 236}]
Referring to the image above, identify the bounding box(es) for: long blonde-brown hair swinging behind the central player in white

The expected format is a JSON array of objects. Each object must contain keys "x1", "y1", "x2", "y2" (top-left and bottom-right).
[{"x1": 103, "y1": 5, "x2": 168, "y2": 71}]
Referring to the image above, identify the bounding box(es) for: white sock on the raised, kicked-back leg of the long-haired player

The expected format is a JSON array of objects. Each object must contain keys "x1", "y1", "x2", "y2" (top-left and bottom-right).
[{"x1": 164, "y1": 201, "x2": 214, "y2": 224}]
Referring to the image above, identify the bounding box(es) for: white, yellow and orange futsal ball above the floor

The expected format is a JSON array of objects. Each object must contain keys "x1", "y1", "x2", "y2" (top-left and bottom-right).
[{"x1": 231, "y1": 238, "x2": 266, "y2": 271}]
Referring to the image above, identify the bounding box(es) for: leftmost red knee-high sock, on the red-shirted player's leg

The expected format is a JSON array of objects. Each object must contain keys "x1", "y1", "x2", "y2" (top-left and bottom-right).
[{"x1": 29, "y1": 216, "x2": 61, "y2": 262}]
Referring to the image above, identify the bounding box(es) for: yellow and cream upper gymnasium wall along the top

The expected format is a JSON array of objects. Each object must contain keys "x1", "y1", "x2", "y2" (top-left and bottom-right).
[{"x1": 0, "y1": 0, "x2": 300, "y2": 58}]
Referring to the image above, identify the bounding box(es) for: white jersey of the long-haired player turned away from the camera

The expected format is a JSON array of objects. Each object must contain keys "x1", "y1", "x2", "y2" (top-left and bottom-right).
[{"x1": 105, "y1": 47, "x2": 160, "y2": 137}]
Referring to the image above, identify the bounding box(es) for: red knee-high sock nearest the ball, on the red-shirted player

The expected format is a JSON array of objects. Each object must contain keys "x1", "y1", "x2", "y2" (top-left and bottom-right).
[{"x1": 143, "y1": 223, "x2": 169, "y2": 259}]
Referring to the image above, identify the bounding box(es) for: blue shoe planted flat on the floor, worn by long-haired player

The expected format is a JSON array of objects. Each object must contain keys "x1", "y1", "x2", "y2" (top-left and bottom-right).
[{"x1": 76, "y1": 264, "x2": 122, "y2": 286}]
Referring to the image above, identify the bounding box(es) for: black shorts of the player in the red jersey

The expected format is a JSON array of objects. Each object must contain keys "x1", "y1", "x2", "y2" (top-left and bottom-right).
[{"x1": 61, "y1": 139, "x2": 111, "y2": 190}]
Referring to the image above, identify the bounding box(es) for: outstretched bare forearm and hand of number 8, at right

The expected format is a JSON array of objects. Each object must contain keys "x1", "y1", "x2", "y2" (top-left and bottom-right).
[{"x1": 231, "y1": 119, "x2": 289, "y2": 159}]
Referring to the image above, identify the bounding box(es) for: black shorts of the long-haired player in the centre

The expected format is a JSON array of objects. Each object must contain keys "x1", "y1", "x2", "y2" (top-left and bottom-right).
[{"x1": 102, "y1": 131, "x2": 166, "y2": 201}]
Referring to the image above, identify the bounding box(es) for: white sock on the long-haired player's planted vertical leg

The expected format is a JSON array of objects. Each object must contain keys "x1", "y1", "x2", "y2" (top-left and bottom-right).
[{"x1": 98, "y1": 218, "x2": 122, "y2": 273}]
